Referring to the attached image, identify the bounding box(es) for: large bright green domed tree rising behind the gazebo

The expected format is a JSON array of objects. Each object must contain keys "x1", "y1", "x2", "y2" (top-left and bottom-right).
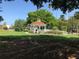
[{"x1": 27, "y1": 9, "x2": 57, "y2": 26}]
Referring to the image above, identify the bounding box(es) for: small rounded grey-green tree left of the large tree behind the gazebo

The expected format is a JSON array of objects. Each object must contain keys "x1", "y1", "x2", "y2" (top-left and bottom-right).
[{"x1": 14, "y1": 19, "x2": 25, "y2": 31}]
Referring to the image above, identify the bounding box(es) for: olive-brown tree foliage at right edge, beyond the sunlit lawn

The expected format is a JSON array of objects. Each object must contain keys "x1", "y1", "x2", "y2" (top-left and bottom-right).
[{"x1": 68, "y1": 12, "x2": 79, "y2": 32}]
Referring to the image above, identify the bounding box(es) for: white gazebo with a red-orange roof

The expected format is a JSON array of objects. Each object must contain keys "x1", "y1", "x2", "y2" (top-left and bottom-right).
[{"x1": 30, "y1": 20, "x2": 46, "y2": 33}]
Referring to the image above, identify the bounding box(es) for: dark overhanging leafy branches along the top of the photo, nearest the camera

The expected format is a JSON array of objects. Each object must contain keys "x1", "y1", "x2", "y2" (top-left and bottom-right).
[{"x1": 0, "y1": 0, "x2": 79, "y2": 13}]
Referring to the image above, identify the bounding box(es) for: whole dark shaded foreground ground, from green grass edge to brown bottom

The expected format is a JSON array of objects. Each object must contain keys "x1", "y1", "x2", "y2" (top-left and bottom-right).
[{"x1": 0, "y1": 35, "x2": 79, "y2": 59}]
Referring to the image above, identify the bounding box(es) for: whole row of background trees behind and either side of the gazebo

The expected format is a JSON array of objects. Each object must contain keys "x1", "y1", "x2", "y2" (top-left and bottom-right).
[{"x1": 14, "y1": 9, "x2": 79, "y2": 32}]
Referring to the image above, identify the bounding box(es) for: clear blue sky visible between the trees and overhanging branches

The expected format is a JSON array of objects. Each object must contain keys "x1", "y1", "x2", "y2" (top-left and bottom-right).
[{"x1": 0, "y1": 0, "x2": 79, "y2": 25}]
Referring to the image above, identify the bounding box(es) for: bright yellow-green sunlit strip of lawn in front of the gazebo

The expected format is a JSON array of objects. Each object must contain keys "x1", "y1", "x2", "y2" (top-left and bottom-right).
[{"x1": 0, "y1": 30, "x2": 79, "y2": 39}]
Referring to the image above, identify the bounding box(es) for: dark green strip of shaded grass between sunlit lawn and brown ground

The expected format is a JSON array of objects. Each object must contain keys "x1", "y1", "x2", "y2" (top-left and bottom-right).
[{"x1": 0, "y1": 35, "x2": 79, "y2": 41}]
